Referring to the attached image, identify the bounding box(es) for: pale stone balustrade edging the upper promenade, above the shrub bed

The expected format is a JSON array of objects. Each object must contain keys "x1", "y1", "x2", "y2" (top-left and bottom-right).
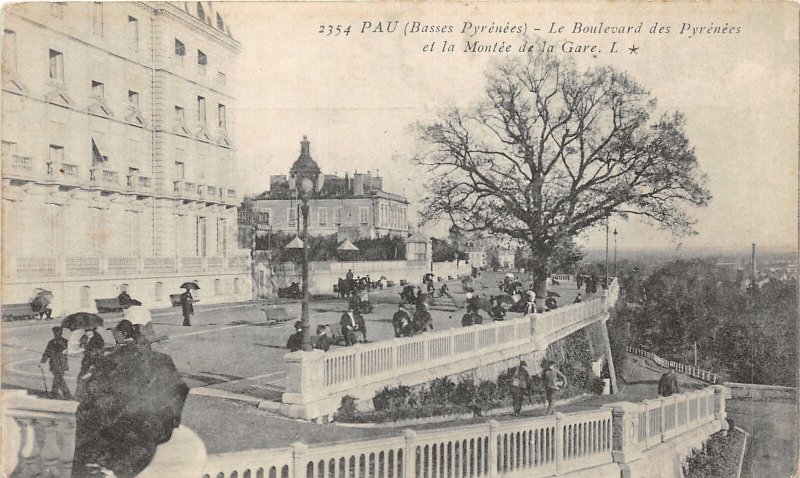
[{"x1": 281, "y1": 283, "x2": 616, "y2": 419}]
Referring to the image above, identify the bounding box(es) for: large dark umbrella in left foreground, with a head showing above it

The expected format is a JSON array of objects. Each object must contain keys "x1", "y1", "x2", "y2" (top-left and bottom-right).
[{"x1": 72, "y1": 320, "x2": 189, "y2": 478}]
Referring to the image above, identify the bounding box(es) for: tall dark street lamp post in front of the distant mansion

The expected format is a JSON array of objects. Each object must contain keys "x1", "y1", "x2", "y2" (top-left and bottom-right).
[{"x1": 289, "y1": 136, "x2": 322, "y2": 351}]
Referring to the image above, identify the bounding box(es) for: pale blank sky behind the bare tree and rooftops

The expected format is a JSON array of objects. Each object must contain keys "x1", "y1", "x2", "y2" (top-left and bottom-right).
[{"x1": 219, "y1": 2, "x2": 798, "y2": 250}]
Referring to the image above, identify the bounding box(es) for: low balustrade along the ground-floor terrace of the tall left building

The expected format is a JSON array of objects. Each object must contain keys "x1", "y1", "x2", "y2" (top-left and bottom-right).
[{"x1": 3, "y1": 256, "x2": 250, "y2": 278}]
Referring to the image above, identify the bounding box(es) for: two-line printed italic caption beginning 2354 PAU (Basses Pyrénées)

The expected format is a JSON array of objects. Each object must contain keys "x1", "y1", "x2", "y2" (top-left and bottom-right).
[{"x1": 317, "y1": 20, "x2": 742, "y2": 54}]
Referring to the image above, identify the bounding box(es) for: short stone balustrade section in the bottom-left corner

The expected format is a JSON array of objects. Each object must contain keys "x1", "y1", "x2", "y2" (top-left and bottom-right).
[{"x1": 0, "y1": 390, "x2": 78, "y2": 477}]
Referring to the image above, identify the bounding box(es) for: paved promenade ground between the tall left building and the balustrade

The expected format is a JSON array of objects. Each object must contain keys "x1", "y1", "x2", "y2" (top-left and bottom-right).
[{"x1": 2, "y1": 274, "x2": 588, "y2": 453}]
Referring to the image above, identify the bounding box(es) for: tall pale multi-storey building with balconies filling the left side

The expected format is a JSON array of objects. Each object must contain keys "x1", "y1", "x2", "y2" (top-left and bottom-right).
[{"x1": 2, "y1": 2, "x2": 251, "y2": 309}]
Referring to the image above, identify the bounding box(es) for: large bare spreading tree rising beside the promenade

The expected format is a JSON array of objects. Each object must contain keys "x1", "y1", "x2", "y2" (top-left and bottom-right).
[{"x1": 414, "y1": 39, "x2": 711, "y2": 304}]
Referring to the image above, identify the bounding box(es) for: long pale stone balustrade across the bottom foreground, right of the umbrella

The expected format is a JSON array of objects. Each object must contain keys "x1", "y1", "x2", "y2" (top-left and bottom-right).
[{"x1": 203, "y1": 386, "x2": 726, "y2": 478}]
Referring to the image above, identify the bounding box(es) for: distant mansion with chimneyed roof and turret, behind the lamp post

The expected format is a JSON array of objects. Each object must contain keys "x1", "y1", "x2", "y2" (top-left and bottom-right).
[{"x1": 252, "y1": 138, "x2": 408, "y2": 240}]
